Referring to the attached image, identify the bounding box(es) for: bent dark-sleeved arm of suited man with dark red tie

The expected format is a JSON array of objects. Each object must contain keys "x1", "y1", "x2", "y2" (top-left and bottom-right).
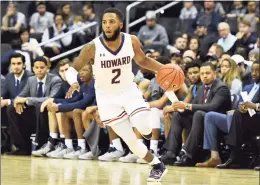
[{"x1": 191, "y1": 86, "x2": 230, "y2": 112}]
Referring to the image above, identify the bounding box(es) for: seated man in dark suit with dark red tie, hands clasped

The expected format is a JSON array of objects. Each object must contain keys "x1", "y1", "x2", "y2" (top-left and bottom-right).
[{"x1": 161, "y1": 62, "x2": 231, "y2": 166}]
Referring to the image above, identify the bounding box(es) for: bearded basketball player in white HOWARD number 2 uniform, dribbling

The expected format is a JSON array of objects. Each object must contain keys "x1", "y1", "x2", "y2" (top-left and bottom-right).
[{"x1": 68, "y1": 8, "x2": 167, "y2": 181}]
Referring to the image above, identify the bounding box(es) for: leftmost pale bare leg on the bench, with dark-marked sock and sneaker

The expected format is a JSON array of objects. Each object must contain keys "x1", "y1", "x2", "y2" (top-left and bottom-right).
[{"x1": 32, "y1": 111, "x2": 58, "y2": 156}]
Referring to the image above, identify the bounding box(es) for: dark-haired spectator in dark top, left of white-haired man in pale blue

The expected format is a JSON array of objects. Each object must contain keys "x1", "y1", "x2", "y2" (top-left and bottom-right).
[{"x1": 194, "y1": 22, "x2": 217, "y2": 58}]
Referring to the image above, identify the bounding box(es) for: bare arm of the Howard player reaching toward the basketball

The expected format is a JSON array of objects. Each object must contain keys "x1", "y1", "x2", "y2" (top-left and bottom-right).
[{"x1": 131, "y1": 35, "x2": 163, "y2": 72}]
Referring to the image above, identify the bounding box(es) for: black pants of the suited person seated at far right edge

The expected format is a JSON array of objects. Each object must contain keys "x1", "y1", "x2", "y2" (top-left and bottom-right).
[{"x1": 226, "y1": 110, "x2": 260, "y2": 148}]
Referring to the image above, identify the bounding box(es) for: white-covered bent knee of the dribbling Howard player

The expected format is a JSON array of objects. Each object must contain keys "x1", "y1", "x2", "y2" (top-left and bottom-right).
[{"x1": 130, "y1": 111, "x2": 152, "y2": 135}]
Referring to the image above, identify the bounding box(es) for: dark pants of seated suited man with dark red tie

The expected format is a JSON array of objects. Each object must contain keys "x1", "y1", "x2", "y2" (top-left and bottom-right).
[{"x1": 163, "y1": 111, "x2": 205, "y2": 158}]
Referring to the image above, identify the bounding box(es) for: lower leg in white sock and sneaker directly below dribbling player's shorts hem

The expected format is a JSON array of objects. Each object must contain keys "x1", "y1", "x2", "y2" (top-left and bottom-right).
[{"x1": 98, "y1": 127, "x2": 125, "y2": 161}]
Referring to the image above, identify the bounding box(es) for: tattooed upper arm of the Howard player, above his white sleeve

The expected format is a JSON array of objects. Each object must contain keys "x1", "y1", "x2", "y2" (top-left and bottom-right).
[{"x1": 72, "y1": 41, "x2": 96, "y2": 71}]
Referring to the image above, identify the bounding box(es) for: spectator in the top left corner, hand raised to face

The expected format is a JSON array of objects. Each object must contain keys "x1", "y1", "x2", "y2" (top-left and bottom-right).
[{"x1": 1, "y1": 2, "x2": 26, "y2": 43}]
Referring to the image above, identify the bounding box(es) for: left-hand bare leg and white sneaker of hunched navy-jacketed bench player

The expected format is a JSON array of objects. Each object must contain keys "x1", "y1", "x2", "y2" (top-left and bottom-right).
[{"x1": 50, "y1": 112, "x2": 74, "y2": 158}]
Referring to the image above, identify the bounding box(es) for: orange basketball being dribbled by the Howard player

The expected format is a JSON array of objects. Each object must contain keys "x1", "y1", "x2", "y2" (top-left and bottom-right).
[{"x1": 156, "y1": 64, "x2": 185, "y2": 91}]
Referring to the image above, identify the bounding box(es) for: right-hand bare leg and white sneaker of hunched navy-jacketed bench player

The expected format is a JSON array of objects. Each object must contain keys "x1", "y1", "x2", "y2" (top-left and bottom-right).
[{"x1": 63, "y1": 109, "x2": 88, "y2": 159}]
